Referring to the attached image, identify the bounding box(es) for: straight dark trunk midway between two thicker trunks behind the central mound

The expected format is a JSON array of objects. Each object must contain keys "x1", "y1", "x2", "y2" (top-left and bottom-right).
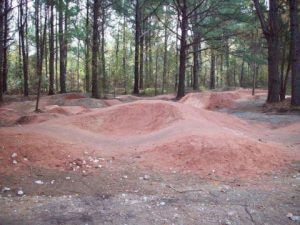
[{"x1": 133, "y1": 0, "x2": 141, "y2": 95}]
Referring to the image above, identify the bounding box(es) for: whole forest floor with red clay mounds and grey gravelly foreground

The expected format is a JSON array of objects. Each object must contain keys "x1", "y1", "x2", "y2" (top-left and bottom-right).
[{"x1": 0, "y1": 89, "x2": 300, "y2": 225}]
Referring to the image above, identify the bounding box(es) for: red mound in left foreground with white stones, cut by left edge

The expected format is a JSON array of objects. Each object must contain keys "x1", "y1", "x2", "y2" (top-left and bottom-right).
[{"x1": 0, "y1": 129, "x2": 88, "y2": 174}]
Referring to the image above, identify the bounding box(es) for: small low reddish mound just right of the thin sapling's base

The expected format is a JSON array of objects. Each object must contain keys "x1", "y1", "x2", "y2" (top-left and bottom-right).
[{"x1": 45, "y1": 105, "x2": 90, "y2": 116}]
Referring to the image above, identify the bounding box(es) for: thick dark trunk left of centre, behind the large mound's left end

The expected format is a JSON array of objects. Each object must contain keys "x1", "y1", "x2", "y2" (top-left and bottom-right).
[{"x1": 92, "y1": 0, "x2": 100, "y2": 98}]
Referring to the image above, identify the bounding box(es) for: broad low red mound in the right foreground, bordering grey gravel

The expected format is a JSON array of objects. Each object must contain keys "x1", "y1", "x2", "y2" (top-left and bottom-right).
[{"x1": 141, "y1": 134, "x2": 292, "y2": 178}]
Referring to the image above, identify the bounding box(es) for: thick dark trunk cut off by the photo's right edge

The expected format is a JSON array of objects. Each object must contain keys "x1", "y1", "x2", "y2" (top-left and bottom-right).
[{"x1": 290, "y1": 0, "x2": 300, "y2": 106}]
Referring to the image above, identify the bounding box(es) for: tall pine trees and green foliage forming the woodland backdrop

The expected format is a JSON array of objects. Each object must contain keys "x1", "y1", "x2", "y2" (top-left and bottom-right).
[{"x1": 0, "y1": 0, "x2": 300, "y2": 109}]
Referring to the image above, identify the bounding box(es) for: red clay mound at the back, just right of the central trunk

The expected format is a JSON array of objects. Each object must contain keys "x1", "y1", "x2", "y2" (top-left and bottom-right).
[{"x1": 180, "y1": 91, "x2": 241, "y2": 110}]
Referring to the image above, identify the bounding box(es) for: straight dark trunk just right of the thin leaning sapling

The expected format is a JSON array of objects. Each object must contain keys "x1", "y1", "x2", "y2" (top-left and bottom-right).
[{"x1": 49, "y1": 2, "x2": 55, "y2": 95}]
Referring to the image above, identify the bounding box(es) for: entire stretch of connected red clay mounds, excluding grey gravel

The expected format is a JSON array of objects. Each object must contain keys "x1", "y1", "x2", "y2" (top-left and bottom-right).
[{"x1": 0, "y1": 90, "x2": 300, "y2": 179}]
